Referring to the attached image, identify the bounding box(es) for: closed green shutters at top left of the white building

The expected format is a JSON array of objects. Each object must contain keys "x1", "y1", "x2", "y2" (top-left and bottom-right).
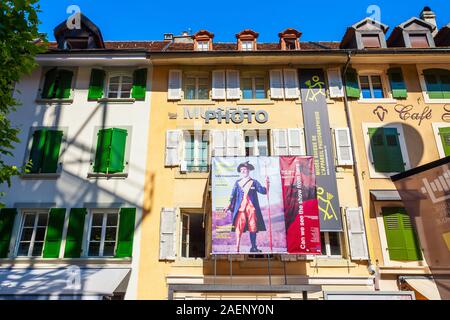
[{"x1": 41, "y1": 68, "x2": 73, "y2": 99}]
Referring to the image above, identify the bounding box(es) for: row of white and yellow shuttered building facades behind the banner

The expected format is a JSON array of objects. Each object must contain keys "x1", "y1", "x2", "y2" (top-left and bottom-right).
[{"x1": 0, "y1": 8, "x2": 450, "y2": 299}]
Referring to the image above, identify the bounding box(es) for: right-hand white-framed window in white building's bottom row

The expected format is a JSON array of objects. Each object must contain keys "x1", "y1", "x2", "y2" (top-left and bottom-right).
[{"x1": 88, "y1": 210, "x2": 119, "y2": 257}]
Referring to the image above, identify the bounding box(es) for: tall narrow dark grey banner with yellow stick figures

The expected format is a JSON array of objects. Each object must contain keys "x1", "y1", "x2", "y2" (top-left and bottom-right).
[{"x1": 300, "y1": 69, "x2": 342, "y2": 231}]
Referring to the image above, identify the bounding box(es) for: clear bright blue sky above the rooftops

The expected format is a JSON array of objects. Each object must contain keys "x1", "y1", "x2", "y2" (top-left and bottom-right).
[{"x1": 40, "y1": 0, "x2": 450, "y2": 42}]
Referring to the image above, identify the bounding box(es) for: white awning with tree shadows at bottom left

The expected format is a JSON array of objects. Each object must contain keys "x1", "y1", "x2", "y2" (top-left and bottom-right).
[{"x1": 0, "y1": 266, "x2": 130, "y2": 297}]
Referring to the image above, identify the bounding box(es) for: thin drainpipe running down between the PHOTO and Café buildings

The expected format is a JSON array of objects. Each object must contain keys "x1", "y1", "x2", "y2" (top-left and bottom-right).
[{"x1": 342, "y1": 50, "x2": 379, "y2": 287}]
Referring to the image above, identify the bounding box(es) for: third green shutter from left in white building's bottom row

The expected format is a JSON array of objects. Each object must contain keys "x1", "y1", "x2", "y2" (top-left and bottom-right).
[{"x1": 64, "y1": 208, "x2": 87, "y2": 258}]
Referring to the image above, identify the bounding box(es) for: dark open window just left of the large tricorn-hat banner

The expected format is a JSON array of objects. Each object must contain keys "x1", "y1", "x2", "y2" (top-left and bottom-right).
[{"x1": 181, "y1": 213, "x2": 205, "y2": 258}]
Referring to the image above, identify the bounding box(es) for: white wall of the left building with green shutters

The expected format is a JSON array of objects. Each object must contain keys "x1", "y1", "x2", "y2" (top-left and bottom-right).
[{"x1": 0, "y1": 66, "x2": 152, "y2": 298}]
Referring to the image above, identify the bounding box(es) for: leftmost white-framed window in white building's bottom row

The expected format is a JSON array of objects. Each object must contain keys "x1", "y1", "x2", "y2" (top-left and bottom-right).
[{"x1": 17, "y1": 211, "x2": 48, "y2": 257}]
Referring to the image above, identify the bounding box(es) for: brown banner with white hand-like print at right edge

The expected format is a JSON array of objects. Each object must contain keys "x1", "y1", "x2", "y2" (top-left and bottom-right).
[{"x1": 391, "y1": 157, "x2": 450, "y2": 300}]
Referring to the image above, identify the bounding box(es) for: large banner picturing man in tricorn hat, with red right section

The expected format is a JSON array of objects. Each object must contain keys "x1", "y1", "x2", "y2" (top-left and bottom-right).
[{"x1": 211, "y1": 157, "x2": 321, "y2": 254}]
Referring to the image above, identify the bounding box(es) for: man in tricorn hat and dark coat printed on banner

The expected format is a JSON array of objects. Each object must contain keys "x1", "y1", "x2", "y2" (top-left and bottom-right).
[{"x1": 225, "y1": 161, "x2": 269, "y2": 252}]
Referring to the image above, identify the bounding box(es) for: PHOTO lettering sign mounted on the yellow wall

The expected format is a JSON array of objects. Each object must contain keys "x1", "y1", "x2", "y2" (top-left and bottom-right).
[{"x1": 183, "y1": 107, "x2": 269, "y2": 124}]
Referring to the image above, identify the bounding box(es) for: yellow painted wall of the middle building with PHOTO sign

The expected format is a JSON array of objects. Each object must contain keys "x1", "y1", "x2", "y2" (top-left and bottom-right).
[{"x1": 138, "y1": 66, "x2": 369, "y2": 299}]
